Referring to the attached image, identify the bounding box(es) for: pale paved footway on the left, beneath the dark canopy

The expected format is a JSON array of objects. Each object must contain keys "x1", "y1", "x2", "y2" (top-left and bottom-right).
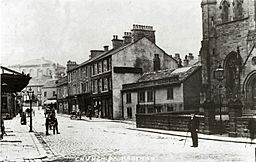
[{"x1": 0, "y1": 110, "x2": 47, "y2": 161}]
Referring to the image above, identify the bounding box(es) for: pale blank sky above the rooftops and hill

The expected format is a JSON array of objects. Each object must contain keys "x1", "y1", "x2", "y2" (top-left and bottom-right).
[{"x1": 0, "y1": 0, "x2": 202, "y2": 66}]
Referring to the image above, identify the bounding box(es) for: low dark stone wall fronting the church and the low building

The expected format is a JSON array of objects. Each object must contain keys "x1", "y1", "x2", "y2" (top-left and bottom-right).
[{"x1": 136, "y1": 114, "x2": 254, "y2": 137}]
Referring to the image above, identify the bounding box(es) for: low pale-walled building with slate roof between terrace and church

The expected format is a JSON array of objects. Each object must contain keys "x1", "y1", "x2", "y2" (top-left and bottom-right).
[{"x1": 122, "y1": 65, "x2": 201, "y2": 119}]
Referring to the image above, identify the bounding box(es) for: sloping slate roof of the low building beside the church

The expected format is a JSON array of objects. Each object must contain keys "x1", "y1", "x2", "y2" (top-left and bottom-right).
[{"x1": 137, "y1": 65, "x2": 201, "y2": 82}]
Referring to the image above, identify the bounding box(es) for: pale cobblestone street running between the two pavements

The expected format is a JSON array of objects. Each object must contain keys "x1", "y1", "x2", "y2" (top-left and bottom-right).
[{"x1": 28, "y1": 111, "x2": 255, "y2": 162}]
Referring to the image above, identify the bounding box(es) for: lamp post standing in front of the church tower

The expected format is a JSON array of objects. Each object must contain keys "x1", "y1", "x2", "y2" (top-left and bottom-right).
[{"x1": 214, "y1": 65, "x2": 224, "y2": 134}]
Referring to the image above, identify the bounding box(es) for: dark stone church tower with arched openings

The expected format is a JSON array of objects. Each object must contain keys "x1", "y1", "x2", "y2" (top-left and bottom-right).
[{"x1": 200, "y1": 0, "x2": 256, "y2": 114}]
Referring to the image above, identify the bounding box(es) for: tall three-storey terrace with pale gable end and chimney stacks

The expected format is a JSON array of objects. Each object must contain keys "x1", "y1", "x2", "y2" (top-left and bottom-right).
[{"x1": 67, "y1": 25, "x2": 178, "y2": 119}]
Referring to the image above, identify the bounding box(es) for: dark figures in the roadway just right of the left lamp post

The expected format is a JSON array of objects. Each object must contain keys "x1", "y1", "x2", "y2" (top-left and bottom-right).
[{"x1": 45, "y1": 109, "x2": 60, "y2": 135}]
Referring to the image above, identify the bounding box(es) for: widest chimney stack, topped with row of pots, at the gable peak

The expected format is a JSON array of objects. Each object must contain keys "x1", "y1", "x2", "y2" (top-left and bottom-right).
[{"x1": 132, "y1": 24, "x2": 156, "y2": 43}]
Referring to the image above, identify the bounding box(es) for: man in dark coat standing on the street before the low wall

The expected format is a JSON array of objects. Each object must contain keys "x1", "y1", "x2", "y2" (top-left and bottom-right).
[{"x1": 188, "y1": 114, "x2": 199, "y2": 147}]
